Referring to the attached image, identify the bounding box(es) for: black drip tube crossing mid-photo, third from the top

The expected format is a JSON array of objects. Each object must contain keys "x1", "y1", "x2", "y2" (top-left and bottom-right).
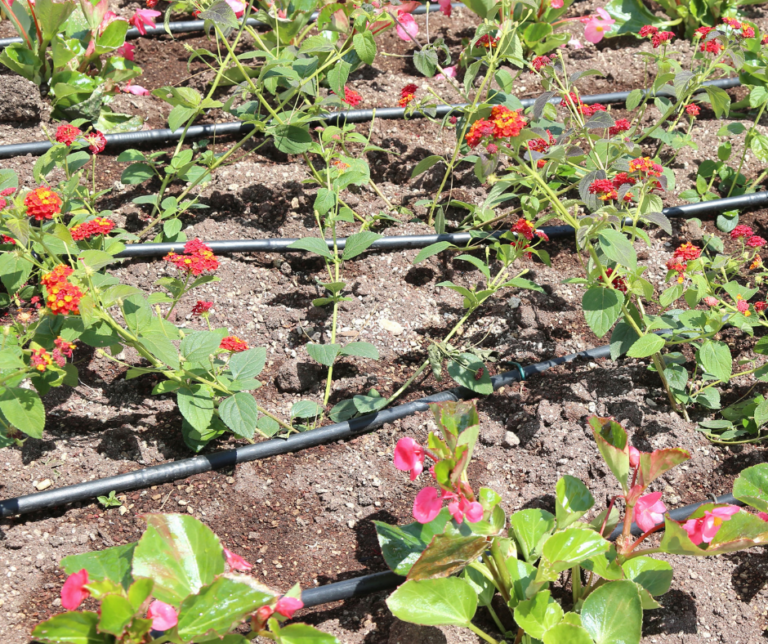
[{"x1": 115, "y1": 191, "x2": 768, "y2": 259}]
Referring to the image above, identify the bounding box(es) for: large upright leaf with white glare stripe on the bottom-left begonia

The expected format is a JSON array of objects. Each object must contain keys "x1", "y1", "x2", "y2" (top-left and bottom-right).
[{"x1": 133, "y1": 514, "x2": 224, "y2": 606}]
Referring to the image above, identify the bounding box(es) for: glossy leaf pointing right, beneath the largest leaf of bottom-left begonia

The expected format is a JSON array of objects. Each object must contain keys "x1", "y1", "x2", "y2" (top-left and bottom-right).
[{"x1": 177, "y1": 574, "x2": 274, "y2": 641}]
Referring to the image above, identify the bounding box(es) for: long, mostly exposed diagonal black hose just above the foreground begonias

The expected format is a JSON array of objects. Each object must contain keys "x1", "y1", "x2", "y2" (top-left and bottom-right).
[{"x1": 0, "y1": 346, "x2": 610, "y2": 517}]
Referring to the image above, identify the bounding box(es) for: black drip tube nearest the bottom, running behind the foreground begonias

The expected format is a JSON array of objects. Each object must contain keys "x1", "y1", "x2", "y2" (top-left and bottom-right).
[{"x1": 301, "y1": 494, "x2": 744, "y2": 608}]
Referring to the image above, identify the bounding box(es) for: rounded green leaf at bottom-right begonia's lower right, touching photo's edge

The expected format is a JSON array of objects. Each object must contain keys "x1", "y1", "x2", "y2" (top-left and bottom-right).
[{"x1": 581, "y1": 581, "x2": 643, "y2": 644}]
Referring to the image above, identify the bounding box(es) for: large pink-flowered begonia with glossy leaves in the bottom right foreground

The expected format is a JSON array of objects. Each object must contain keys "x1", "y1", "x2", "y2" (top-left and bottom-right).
[{"x1": 376, "y1": 403, "x2": 768, "y2": 644}]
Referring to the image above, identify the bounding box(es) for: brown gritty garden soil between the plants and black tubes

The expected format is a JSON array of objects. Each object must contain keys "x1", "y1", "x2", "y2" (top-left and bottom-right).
[{"x1": 0, "y1": 3, "x2": 768, "y2": 644}]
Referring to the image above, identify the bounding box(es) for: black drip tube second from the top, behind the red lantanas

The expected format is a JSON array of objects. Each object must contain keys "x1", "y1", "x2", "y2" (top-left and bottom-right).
[{"x1": 0, "y1": 78, "x2": 741, "y2": 159}]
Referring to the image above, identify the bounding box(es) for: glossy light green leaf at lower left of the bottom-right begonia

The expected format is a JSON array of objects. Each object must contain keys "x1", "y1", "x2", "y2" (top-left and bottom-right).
[{"x1": 387, "y1": 577, "x2": 477, "y2": 627}]
